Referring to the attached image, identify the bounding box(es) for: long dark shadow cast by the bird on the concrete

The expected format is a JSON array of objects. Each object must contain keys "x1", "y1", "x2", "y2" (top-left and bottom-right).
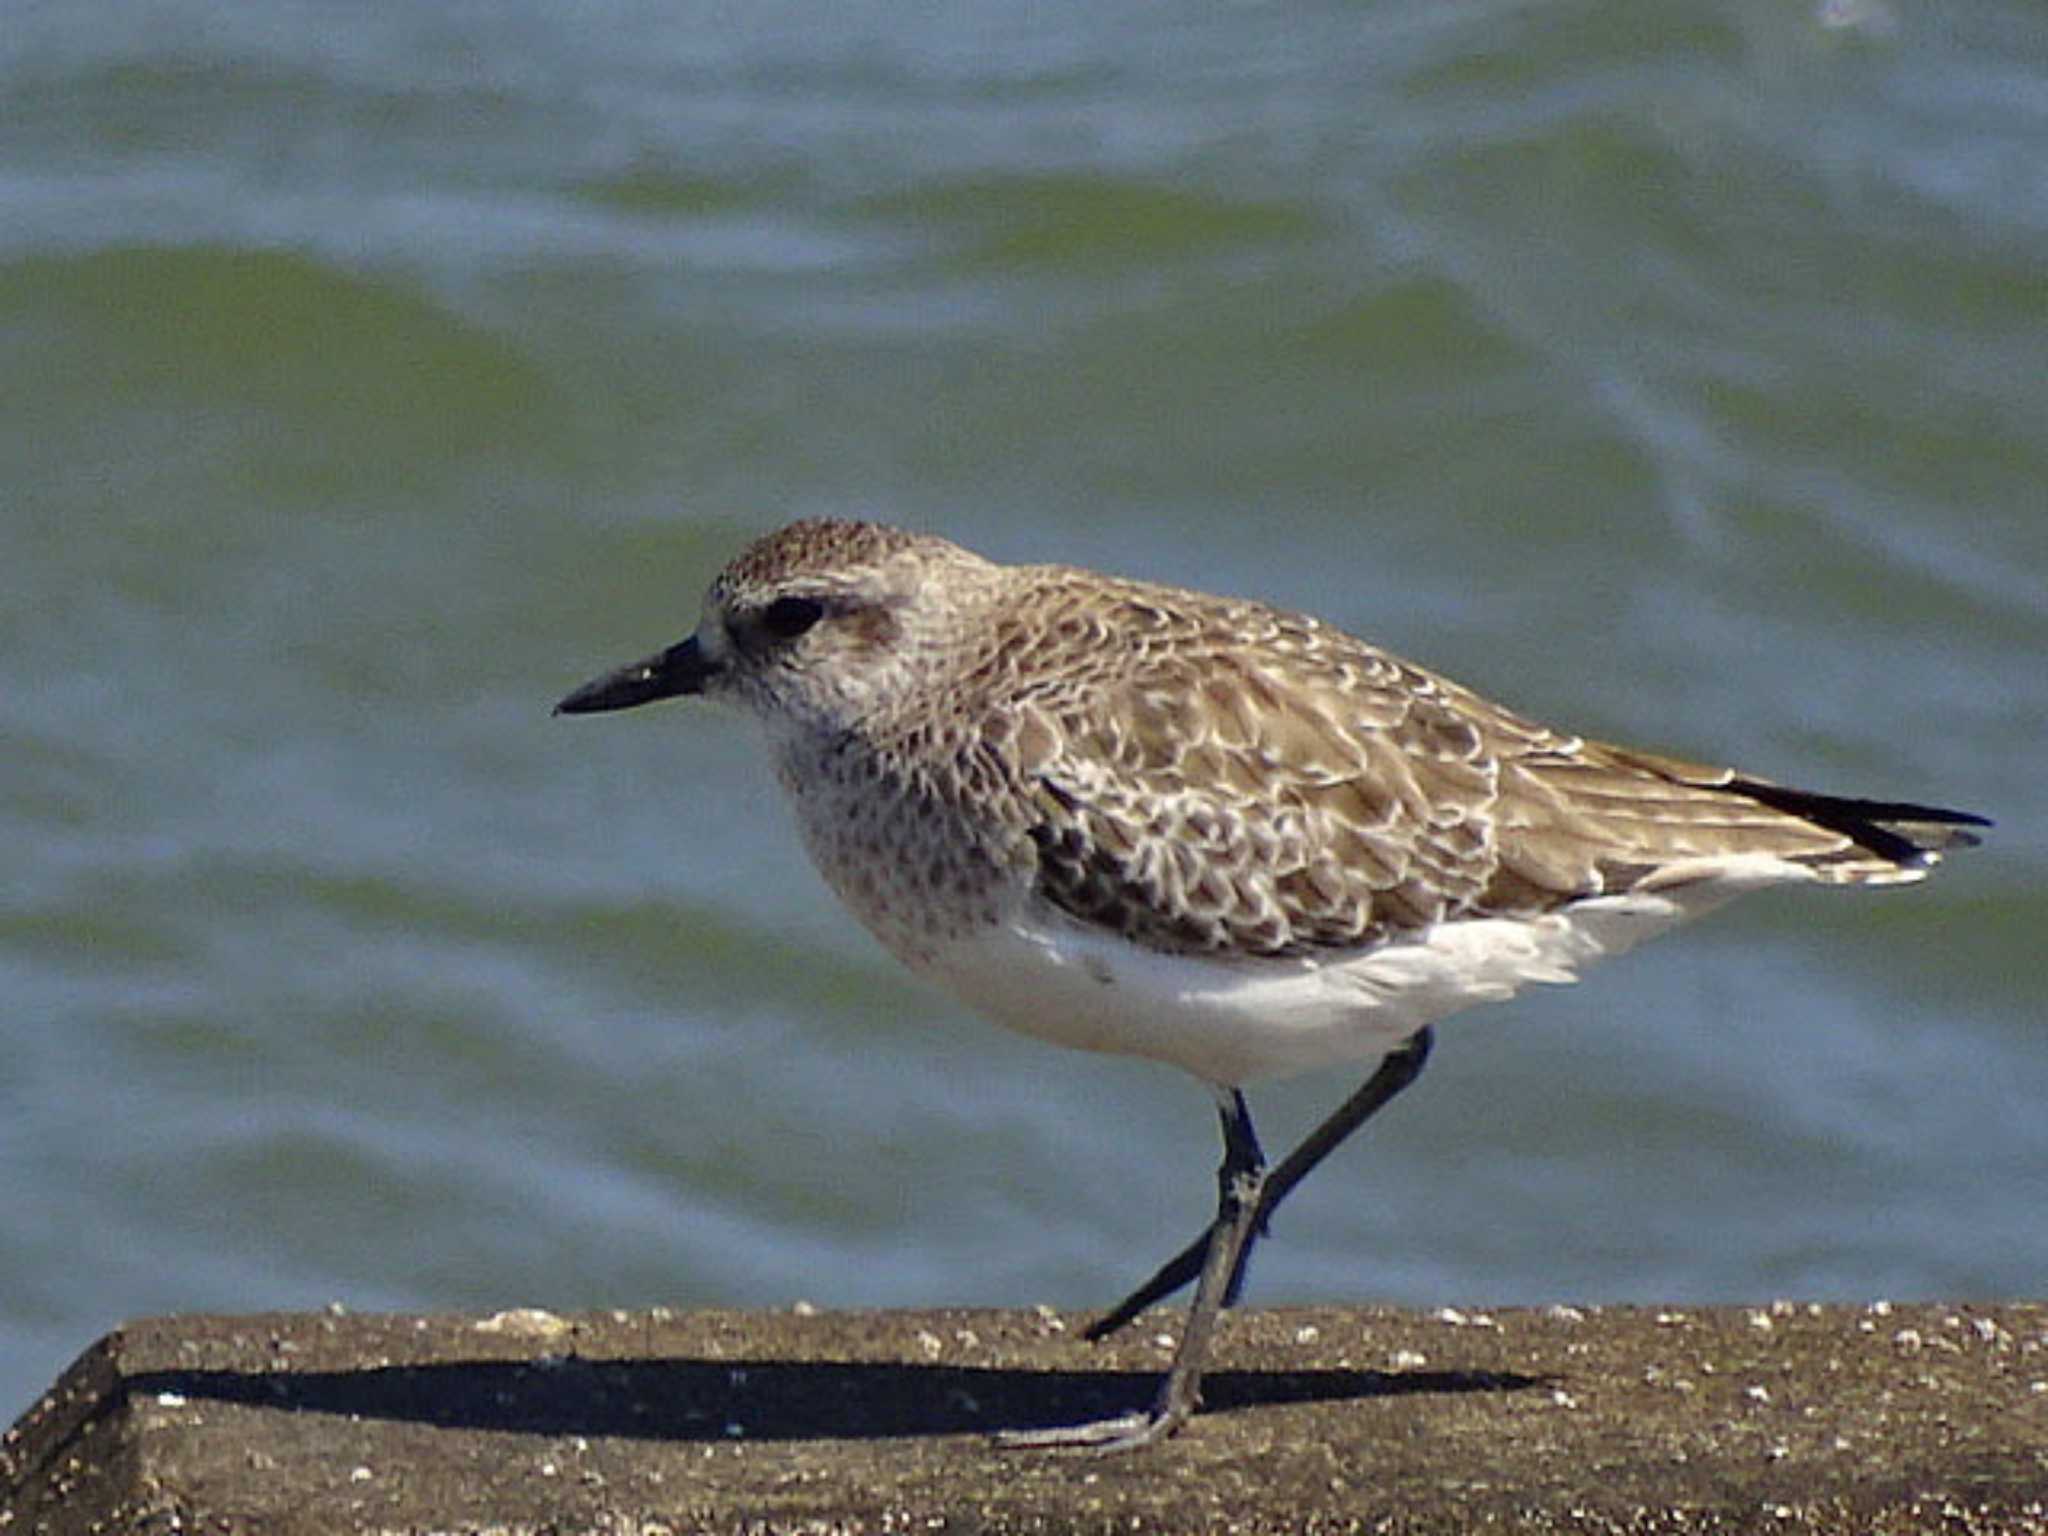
[{"x1": 123, "y1": 1356, "x2": 1544, "y2": 1440}]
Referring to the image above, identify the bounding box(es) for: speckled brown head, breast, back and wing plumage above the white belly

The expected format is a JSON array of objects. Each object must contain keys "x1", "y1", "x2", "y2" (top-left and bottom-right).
[{"x1": 679, "y1": 522, "x2": 1960, "y2": 991}]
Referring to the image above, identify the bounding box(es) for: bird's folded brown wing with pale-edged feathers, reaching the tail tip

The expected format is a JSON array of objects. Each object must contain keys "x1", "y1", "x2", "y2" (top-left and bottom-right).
[{"x1": 1003, "y1": 584, "x2": 1950, "y2": 954}]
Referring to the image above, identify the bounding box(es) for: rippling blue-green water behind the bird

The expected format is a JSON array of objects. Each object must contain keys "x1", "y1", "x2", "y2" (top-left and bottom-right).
[{"x1": 0, "y1": 0, "x2": 2048, "y2": 1413}]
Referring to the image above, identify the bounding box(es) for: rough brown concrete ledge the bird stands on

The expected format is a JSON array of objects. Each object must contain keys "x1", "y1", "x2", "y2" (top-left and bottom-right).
[{"x1": 0, "y1": 1303, "x2": 2048, "y2": 1536}]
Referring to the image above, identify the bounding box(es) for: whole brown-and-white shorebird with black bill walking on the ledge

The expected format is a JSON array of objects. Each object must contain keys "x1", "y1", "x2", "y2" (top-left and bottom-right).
[{"x1": 555, "y1": 520, "x2": 1991, "y2": 1452}]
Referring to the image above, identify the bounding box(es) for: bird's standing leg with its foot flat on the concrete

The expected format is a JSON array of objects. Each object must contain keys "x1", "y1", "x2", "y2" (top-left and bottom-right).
[{"x1": 997, "y1": 1087, "x2": 1266, "y2": 1452}]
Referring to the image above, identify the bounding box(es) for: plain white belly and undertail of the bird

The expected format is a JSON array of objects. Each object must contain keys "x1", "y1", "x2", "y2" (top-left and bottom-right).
[{"x1": 920, "y1": 858, "x2": 1812, "y2": 1085}]
